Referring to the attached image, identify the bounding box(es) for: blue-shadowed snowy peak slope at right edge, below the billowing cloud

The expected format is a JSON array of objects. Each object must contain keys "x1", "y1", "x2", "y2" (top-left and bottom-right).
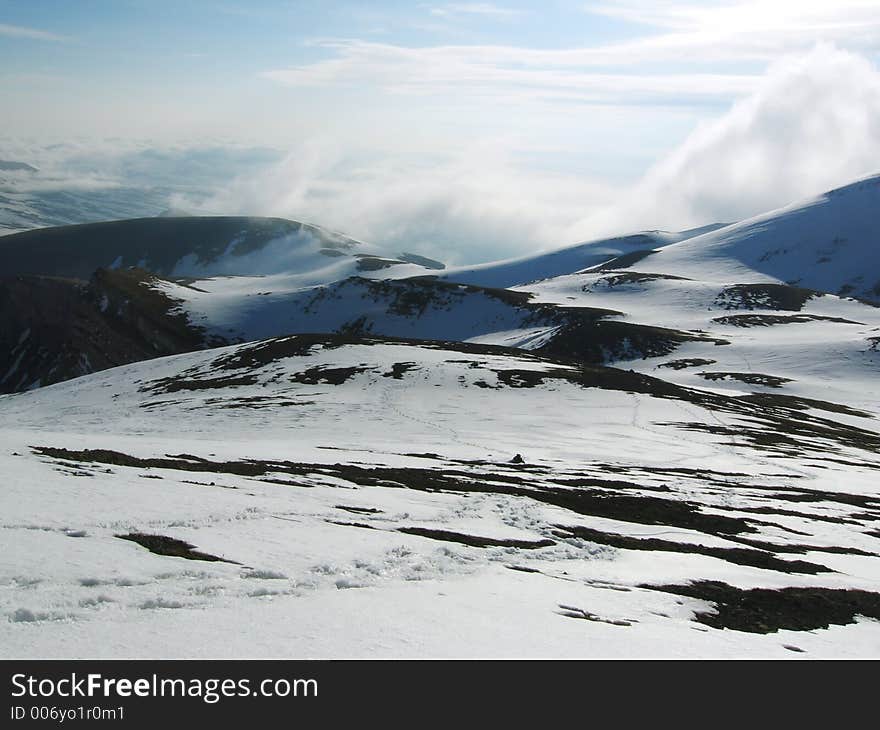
[{"x1": 621, "y1": 175, "x2": 880, "y2": 302}]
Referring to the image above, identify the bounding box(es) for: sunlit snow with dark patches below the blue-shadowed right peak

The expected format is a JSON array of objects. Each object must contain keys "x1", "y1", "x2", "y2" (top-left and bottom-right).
[{"x1": 524, "y1": 270, "x2": 880, "y2": 411}]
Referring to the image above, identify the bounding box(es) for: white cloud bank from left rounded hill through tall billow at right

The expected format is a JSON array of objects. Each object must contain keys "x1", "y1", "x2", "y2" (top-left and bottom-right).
[{"x1": 178, "y1": 45, "x2": 880, "y2": 263}]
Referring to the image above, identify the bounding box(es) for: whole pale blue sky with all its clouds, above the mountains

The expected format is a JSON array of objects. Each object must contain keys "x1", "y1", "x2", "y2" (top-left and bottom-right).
[{"x1": 0, "y1": 0, "x2": 880, "y2": 262}]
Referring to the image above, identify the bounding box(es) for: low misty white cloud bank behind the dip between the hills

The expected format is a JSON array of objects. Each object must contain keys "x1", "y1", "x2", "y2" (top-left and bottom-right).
[{"x1": 174, "y1": 140, "x2": 616, "y2": 263}]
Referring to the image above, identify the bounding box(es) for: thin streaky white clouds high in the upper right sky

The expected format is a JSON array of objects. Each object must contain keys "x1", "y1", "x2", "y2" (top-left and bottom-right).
[{"x1": 261, "y1": 0, "x2": 880, "y2": 105}]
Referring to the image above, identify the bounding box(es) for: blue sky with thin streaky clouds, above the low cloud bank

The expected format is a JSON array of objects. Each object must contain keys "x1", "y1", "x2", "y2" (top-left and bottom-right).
[{"x1": 0, "y1": 0, "x2": 860, "y2": 148}]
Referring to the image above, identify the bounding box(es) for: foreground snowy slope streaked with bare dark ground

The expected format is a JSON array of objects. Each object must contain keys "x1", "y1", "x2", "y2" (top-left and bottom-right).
[{"x1": 0, "y1": 336, "x2": 880, "y2": 657}]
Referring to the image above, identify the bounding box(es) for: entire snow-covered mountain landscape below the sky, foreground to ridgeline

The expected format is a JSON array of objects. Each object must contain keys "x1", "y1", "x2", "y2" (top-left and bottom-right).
[{"x1": 0, "y1": 171, "x2": 880, "y2": 657}]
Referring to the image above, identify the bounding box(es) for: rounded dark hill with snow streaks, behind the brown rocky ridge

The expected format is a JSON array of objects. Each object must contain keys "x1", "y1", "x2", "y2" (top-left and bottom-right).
[{"x1": 0, "y1": 216, "x2": 443, "y2": 285}]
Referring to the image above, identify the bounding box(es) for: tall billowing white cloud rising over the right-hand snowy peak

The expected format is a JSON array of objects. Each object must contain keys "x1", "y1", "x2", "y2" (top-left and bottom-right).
[{"x1": 573, "y1": 45, "x2": 880, "y2": 235}]
